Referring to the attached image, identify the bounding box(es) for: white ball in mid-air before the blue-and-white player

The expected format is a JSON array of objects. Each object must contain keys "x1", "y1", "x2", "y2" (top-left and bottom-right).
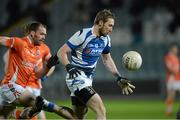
[{"x1": 122, "y1": 51, "x2": 142, "y2": 71}]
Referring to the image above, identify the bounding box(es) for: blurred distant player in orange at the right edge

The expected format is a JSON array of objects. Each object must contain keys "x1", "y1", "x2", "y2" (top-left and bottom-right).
[{"x1": 165, "y1": 43, "x2": 180, "y2": 115}]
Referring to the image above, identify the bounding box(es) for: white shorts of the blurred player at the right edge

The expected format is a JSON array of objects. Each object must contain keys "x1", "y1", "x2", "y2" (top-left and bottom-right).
[{"x1": 167, "y1": 80, "x2": 180, "y2": 90}]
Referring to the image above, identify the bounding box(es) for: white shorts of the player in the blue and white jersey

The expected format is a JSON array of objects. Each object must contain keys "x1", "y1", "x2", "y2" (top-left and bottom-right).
[{"x1": 66, "y1": 71, "x2": 92, "y2": 96}]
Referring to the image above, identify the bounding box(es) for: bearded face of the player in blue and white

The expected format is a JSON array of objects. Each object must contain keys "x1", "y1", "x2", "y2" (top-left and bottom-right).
[{"x1": 99, "y1": 18, "x2": 114, "y2": 36}]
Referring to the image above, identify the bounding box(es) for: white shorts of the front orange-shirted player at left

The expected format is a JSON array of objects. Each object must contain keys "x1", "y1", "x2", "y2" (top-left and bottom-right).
[{"x1": 0, "y1": 83, "x2": 26, "y2": 105}]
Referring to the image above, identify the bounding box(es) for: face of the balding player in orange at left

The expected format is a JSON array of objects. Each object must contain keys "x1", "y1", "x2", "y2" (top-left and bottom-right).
[{"x1": 33, "y1": 26, "x2": 47, "y2": 45}]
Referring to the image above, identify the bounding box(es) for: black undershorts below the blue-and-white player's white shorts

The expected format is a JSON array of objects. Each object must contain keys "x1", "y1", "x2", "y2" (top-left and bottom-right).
[{"x1": 71, "y1": 86, "x2": 96, "y2": 106}]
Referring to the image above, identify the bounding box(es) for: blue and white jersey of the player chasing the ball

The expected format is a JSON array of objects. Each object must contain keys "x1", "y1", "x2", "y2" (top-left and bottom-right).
[{"x1": 67, "y1": 28, "x2": 111, "y2": 69}]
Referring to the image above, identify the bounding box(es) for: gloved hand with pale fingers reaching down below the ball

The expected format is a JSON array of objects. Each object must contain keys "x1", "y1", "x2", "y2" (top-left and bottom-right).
[{"x1": 117, "y1": 76, "x2": 135, "y2": 95}]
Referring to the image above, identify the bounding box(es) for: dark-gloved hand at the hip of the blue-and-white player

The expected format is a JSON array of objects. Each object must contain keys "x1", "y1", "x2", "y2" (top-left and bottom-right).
[{"x1": 65, "y1": 64, "x2": 81, "y2": 79}]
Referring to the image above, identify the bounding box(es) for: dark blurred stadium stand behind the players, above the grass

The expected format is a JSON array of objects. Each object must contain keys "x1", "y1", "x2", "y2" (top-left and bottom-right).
[{"x1": 0, "y1": 0, "x2": 180, "y2": 99}]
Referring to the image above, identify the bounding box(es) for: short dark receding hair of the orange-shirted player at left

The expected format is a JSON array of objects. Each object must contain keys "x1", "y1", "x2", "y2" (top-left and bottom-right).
[{"x1": 24, "y1": 22, "x2": 47, "y2": 35}]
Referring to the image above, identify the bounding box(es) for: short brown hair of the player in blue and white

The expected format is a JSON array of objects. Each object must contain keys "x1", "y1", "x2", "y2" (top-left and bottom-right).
[{"x1": 94, "y1": 9, "x2": 115, "y2": 25}]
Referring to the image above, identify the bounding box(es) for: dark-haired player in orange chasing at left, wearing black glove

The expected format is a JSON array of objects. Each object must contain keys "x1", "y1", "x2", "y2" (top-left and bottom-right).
[{"x1": 0, "y1": 22, "x2": 73, "y2": 119}]
